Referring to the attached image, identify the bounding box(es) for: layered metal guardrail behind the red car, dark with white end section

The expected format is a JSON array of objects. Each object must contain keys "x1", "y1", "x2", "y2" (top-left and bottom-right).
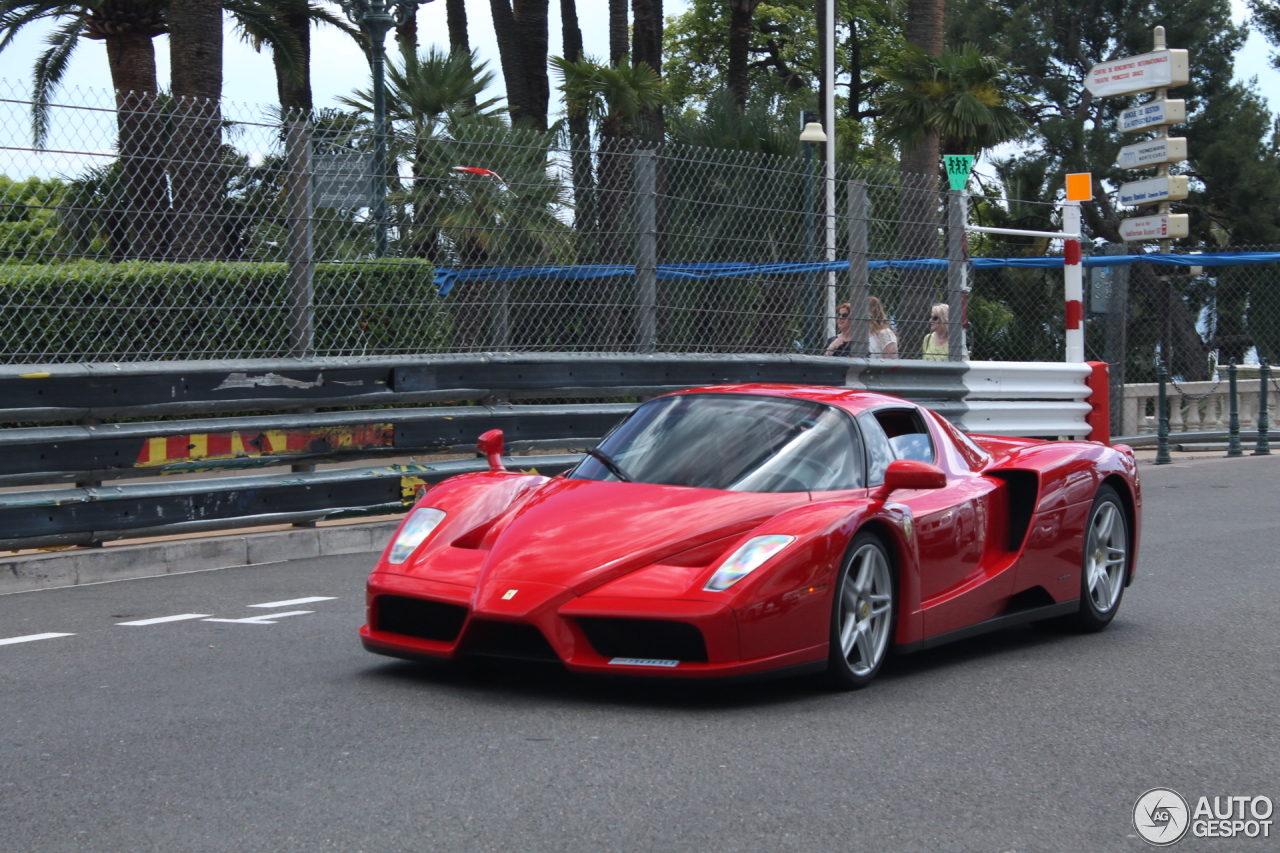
[{"x1": 0, "y1": 353, "x2": 1089, "y2": 549}]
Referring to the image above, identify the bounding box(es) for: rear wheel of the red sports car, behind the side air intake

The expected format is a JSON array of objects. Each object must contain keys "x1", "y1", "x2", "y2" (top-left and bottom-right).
[{"x1": 1076, "y1": 485, "x2": 1130, "y2": 631}]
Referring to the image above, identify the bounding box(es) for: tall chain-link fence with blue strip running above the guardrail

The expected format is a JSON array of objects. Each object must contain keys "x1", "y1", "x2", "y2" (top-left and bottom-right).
[{"x1": 0, "y1": 82, "x2": 1280, "y2": 371}]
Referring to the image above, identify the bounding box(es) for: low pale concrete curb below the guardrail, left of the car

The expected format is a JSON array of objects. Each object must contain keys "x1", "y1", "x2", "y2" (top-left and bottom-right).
[{"x1": 0, "y1": 520, "x2": 399, "y2": 596}]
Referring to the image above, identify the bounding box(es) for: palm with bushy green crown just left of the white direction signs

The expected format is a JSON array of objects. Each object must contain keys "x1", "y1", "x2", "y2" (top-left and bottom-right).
[{"x1": 877, "y1": 45, "x2": 1027, "y2": 352}]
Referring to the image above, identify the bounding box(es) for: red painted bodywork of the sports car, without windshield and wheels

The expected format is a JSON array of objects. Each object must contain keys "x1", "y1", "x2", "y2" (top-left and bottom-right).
[{"x1": 360, "y1": 384, "x2": 1142, "y2": 678}]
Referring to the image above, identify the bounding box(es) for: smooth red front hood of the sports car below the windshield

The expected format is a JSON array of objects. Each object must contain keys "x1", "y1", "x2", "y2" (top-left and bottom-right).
[{"x1": 481, "y1": 480, "x2": 809, "y2": 594}]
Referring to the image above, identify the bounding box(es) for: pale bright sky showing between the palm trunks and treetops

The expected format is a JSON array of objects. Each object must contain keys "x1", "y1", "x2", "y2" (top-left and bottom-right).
[{"x1": 0, "y1": 0, "x2": 1280, "y2": 126}]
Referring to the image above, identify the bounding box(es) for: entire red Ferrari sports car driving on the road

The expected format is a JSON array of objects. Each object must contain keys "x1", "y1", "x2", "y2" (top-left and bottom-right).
[{"x1": 360, "y1": 384, "x2": 1142, "y2": 688}]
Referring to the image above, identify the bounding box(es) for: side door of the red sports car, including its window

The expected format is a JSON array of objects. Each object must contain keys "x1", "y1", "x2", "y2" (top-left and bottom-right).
[{"x1": 858, "y1": 409, "x2": 1011, "y2": 637}]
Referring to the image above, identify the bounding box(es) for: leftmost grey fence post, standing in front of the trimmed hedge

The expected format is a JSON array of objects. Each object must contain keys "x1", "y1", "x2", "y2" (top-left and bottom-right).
[{"x1": 287, "y1": 118, "x2": 315, "y2": 359}]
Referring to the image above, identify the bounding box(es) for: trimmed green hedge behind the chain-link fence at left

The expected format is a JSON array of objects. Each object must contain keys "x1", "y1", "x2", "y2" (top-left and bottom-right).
[{"x1": 0, "y1": 259, "x2": 449, "y2": 364}]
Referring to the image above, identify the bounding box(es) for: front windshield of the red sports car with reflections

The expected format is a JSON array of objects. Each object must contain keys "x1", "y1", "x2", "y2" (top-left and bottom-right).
[{"x1": 570, "y1": 394, "x2": 863, "y2": 492}]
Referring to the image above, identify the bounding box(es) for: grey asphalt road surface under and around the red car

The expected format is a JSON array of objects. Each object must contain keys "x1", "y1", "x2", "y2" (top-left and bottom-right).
[{"x1": 0, "y1": 457, "x2": 1280, "y2": 853}]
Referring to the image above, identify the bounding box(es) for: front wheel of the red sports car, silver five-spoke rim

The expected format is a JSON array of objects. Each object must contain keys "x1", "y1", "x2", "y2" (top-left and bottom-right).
[{"x1": 827, "y1": 532, "x2": 897, "y2": 690}]
